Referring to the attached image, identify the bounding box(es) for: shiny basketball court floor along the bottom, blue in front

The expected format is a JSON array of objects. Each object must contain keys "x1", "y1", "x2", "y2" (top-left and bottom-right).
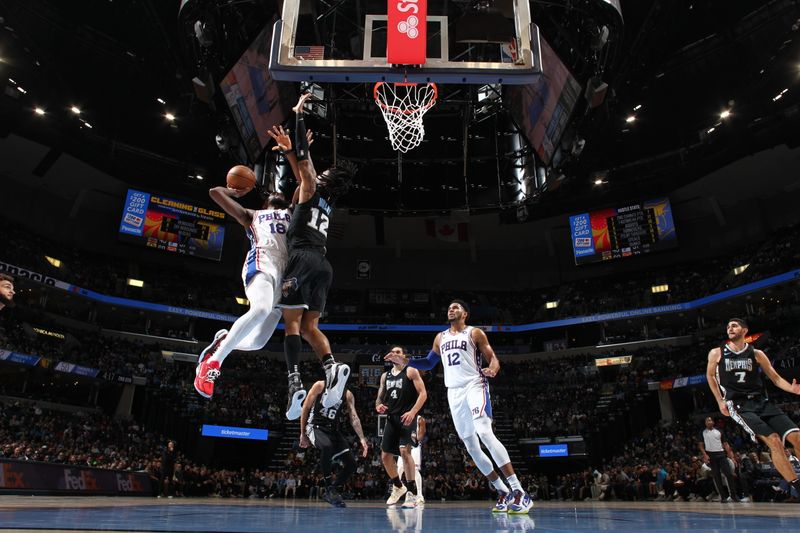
[{"x1": 0, "y1": 496, "x2": 800, "y2": 533}]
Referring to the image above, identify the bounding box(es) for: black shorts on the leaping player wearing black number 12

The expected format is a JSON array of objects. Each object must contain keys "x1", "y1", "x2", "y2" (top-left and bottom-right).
[{"x1": 278, "y1": 248, "x2": 333, "y2": 314}]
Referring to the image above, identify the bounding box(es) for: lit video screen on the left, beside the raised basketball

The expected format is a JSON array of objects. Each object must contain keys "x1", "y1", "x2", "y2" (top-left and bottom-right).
[{"x1": 119, "y1": 189, "x2": 225, "y2": 261}]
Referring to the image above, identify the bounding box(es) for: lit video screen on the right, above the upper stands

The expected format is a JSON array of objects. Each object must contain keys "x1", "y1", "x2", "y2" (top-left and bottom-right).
[{"x1": 569, "y1": 198, "x2": 678, "y2": 265}]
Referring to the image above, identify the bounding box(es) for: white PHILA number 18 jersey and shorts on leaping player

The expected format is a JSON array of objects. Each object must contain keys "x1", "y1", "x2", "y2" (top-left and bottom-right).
[{"x1": 242, "y1": 209, "x2": 292, "y2": 287}]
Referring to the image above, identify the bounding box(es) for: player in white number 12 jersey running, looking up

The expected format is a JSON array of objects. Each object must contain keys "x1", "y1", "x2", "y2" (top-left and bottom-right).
[{"x1": 384, "y1": 300, "x2": 533, "y2": 514}]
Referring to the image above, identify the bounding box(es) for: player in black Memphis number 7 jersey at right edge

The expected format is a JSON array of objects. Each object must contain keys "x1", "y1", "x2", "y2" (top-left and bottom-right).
[{"x1": 706, "y1": 318, "x2": 800, "y2": 491}]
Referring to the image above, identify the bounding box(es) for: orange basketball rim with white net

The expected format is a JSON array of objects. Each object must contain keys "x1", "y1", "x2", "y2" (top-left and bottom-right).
[{"x1": 373, "y1": 81, "x2": 439, "y2": 153}]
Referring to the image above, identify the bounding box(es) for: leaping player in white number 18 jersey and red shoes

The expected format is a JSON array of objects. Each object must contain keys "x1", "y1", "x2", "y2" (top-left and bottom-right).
[{"x1": 194, "y1": 181, "x2": 292, "y2": 398}]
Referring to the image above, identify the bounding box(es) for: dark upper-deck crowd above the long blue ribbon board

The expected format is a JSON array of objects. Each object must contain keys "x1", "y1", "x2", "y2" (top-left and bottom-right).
[{"x1": 0, "y1": 215, "x2": 800, "y2": 324}]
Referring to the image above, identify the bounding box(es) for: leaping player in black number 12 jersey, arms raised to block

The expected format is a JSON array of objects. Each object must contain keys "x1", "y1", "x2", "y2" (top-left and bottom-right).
[{"x1": 269, "y1": 94, "x2": 352, "y2": 420}]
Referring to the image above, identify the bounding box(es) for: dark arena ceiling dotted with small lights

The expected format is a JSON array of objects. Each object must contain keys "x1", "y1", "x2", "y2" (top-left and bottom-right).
[{"x1": 0, "y1": 0, "x2": 800, "y2": 216}]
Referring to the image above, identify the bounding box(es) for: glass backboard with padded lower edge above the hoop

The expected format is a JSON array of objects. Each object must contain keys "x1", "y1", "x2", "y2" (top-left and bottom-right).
[{"x1": 269, "y1": 0, "x2": 542, "y2": 85}]
